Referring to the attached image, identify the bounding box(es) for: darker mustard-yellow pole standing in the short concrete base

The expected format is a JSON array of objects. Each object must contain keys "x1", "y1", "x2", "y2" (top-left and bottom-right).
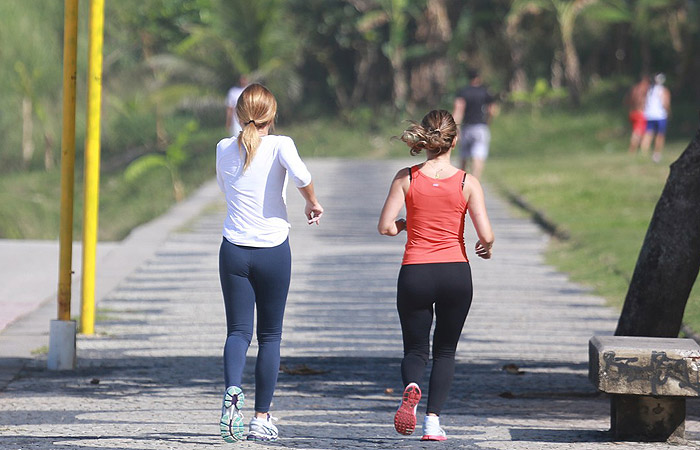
[{"x1": 58, "y1": 0, "x2": 78, "y2": 320}]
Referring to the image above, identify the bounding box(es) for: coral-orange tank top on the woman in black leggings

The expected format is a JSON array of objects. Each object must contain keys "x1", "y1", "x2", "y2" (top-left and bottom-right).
[{"x1": 401, "y1": 166, "x2": 468, "y2": 265}]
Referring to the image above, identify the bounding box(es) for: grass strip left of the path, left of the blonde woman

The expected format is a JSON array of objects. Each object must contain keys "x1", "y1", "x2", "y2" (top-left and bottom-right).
[{"x1": 0, "y1": 125, "x2": 221, "y2": 241}]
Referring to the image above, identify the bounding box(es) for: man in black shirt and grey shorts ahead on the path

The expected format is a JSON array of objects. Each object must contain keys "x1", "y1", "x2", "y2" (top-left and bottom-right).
[{"x1": 452, "y1": 71, "x2": 496, "y2": 178}]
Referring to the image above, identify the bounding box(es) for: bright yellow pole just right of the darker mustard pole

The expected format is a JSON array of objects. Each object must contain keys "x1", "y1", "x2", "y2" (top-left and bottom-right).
[{"x1": 80, "y1": 0, "x2": 104, "y2": 334}]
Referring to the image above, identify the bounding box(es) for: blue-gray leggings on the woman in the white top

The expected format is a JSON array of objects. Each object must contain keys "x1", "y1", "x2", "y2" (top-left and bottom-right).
[{"x1": 219, "y1": 239, "x2": 292, "y2": 413}]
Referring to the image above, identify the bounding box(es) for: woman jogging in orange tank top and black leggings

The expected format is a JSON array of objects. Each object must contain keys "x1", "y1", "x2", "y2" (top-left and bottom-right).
[{"x1": 378, "y1": 110, "x2": 494, "y2": 441}]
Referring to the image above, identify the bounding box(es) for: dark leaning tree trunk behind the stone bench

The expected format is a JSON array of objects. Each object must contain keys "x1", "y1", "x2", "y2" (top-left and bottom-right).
[{"x1": 615, "y1": 121, "x2": 700, "y2": 337}]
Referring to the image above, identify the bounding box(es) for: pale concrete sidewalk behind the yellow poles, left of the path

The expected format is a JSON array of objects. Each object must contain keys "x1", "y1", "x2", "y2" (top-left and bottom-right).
[{"x1": 0, "y1": 181, "x2": 221, "y2": 390}]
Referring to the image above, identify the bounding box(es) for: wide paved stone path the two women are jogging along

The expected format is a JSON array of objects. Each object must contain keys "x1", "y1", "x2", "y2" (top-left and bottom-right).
[{"x1": 0, "y1": 160, "x2": 700, "y2": 450}]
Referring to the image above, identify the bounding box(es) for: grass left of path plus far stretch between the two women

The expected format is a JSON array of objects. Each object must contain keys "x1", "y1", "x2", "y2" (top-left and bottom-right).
[{"x1": 0, "y1": 120, "x2": 402, "y2": 241}]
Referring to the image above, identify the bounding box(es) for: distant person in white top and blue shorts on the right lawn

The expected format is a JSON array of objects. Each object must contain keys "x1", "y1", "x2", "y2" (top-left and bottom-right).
[{"x1": 641, "y1": 73, "x2": 671, "y2": 163}]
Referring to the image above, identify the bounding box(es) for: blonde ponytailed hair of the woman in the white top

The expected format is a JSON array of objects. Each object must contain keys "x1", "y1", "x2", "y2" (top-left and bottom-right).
[{"x1": 236, "y1": 83, "x2": 277, "y2": 171}]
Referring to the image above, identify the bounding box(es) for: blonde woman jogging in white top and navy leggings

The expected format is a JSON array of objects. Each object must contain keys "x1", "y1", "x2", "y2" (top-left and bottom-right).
[{"x1": 216, "y1": 84, "x2": 323, "y2": 442}]
